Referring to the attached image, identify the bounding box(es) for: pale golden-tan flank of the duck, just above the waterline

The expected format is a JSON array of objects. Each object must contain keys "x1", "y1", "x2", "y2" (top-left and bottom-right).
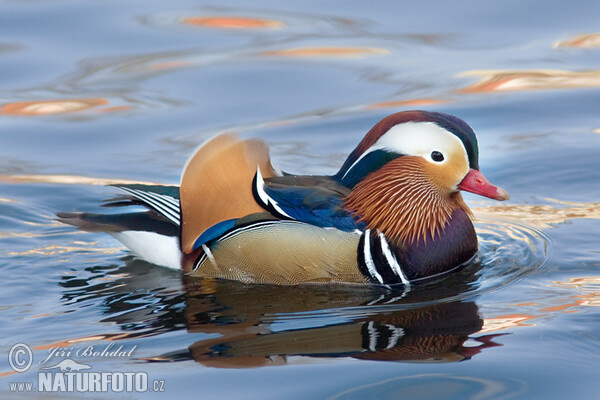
[{"x1": 192, "y1": 222, "x2": 366, "y2": 285}]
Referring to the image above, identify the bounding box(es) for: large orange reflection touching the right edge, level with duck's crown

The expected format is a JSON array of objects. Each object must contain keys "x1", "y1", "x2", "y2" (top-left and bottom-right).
[{"x1": 458, "y1": 69, "x2": 600, "y2": 93}]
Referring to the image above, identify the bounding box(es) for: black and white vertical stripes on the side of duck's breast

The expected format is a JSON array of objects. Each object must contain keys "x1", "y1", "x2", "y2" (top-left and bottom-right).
[{"x1": 358, "y1": 229, "x2": 410, "y2": 288}]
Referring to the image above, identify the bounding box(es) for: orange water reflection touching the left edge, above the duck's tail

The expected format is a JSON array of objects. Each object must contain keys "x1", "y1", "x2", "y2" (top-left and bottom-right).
[{"x1": 0, "y1": 98, "x2": 108, "y2": 117}]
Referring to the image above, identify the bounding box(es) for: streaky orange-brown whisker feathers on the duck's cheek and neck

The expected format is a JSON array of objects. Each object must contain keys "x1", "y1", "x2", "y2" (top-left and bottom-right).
[{"x1": 344, "y1": 156, "x2": 471, "y2": 246}]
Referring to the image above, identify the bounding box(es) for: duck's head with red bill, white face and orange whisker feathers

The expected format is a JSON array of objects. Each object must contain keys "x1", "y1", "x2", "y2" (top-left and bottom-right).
[{"x1": 335, "y1": 111, "x2": 509, "y2": 242}]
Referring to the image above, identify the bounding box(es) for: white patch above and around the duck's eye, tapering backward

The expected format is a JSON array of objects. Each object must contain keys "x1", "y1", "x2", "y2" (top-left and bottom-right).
[{"x1": 344, "y1": 122, "x2": 469, "y2": 176}]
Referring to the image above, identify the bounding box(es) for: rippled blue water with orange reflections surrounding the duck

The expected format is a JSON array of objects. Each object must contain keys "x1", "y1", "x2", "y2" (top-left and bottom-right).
[{"x1": 0, "y1": 0, "x2": 600, "y2": 399}]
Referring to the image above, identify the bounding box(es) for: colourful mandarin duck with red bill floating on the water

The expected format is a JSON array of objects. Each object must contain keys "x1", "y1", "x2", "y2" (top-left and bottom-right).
[{"x1": 57, "y1": 110, "x2": 509, "y2": 287}]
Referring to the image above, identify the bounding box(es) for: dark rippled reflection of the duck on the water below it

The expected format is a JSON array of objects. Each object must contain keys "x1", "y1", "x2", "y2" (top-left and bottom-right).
[{"x1": 63, "y1": 260, "x2": 497, "y2": 368}]
